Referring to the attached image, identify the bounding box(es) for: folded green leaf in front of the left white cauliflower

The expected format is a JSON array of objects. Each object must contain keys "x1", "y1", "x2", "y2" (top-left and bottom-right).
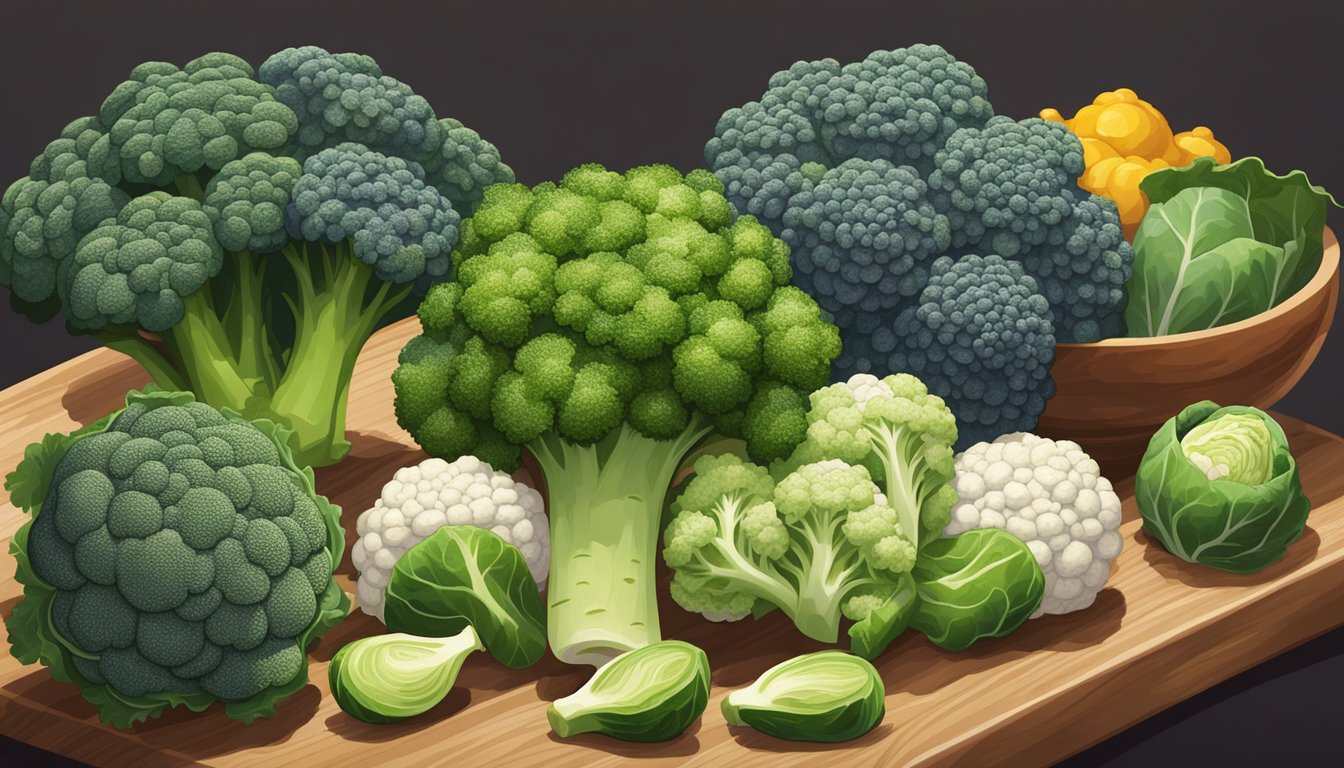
[{"x1": 384, "y1": 526, "x2": 546, "y2": 668}]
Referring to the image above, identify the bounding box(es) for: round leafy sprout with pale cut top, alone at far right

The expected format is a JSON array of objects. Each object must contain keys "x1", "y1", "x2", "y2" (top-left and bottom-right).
[{"x1": 1134, "y1": 399, "x2": 1312, "y2": 573}]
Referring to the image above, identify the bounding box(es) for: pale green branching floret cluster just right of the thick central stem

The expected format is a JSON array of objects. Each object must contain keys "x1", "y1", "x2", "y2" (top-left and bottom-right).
[{"x1": 663, "y1": 455, "x2": 915, "y2": 643}]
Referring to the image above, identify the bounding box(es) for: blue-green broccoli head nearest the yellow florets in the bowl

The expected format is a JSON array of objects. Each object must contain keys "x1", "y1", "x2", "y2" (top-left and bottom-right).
[{"x1": 929, "y1": 117, "x2": 1086, "y2": 258}]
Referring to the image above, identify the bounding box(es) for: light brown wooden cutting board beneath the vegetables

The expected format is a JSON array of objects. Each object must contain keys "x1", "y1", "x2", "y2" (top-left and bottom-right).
[{"x1": 0, "y1": 320, "x2": 1344, "y2": 768}]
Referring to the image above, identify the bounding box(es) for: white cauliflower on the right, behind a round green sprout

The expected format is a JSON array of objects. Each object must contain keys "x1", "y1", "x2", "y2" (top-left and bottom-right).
[{"x1": 942, "y1": 432, "x2": 1122, "y2": 619}]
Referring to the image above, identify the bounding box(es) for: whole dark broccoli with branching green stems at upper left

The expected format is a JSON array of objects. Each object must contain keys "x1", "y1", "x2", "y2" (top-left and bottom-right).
[{"x1": 0, "y1": 47, "x2": 508, "y2": 465}]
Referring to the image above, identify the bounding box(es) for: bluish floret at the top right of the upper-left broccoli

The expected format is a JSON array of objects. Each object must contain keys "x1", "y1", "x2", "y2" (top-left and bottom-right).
[{"x1": 259, "y1": 46, "x2": 442, "y2": 157}]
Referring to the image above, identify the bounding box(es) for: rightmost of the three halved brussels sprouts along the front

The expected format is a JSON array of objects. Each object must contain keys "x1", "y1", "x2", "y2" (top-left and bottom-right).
[{"x1": 723, "y1": 651, "x2": 887, "y2": 741}]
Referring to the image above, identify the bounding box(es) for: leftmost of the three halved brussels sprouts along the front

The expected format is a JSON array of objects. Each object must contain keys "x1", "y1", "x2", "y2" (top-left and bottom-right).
[{"x1": 327, "y1": 627, "x2": 481, "y2": 724}]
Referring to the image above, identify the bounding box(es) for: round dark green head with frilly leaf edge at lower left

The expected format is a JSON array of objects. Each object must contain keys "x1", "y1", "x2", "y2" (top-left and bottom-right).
[{"x1": 7, "y1": 393, "x2": 348, "y2": 728}]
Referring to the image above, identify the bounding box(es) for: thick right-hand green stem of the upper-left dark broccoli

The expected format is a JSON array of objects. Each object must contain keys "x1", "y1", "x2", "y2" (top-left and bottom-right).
[{"x1": 270, "y1": 242, "x2": 411, "y2": 465}]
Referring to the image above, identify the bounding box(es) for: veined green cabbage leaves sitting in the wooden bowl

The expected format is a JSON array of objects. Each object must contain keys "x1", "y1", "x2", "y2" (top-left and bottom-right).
[{"x1": 1125, "y1": 157, "x2": 1337, "y2": 336}]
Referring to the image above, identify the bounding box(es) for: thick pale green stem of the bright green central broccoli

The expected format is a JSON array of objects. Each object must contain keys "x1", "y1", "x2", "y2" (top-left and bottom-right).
[{"x1": 527, "y1": 420, "x2": 708, "y2": 667}]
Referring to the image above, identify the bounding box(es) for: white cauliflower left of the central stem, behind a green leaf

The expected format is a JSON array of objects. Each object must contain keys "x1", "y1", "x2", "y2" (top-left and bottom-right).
[{"x1": 351, "y1": 456, "x2": 551, "y2": 621}]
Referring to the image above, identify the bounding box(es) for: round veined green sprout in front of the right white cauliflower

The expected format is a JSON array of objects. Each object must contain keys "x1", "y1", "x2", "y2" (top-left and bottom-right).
[{"x1": 910, "y1": 529, "x2": 1046, "y2": 651}]
